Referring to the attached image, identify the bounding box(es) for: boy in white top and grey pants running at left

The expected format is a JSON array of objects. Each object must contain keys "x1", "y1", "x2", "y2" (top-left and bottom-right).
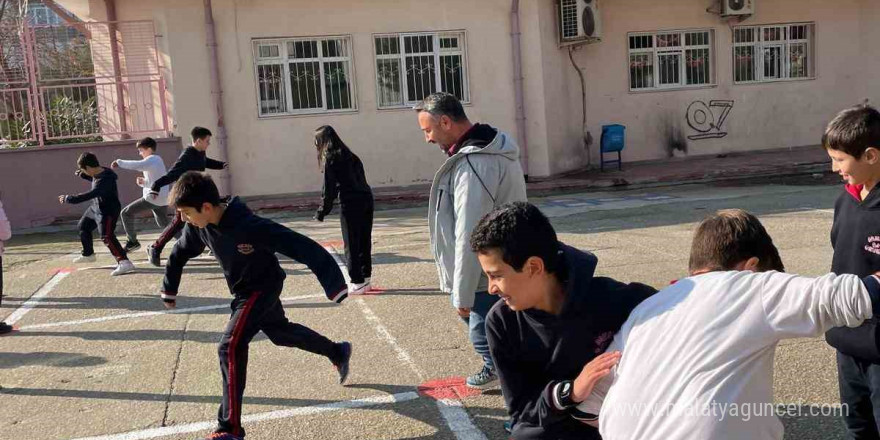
[{"x1": 110, "y1": 137, "x2": 168, "y2": 252}]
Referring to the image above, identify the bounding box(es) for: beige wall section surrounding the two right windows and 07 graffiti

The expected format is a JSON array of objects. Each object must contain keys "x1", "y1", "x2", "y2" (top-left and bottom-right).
[{"x1": 546, "y1": 0, "x2": 880, "y2": 173}]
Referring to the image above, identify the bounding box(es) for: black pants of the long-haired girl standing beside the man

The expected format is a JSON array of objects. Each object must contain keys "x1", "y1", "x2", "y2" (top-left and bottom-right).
[{"x1": 339, "y1": 203, "x2": 373, "y2": 283}]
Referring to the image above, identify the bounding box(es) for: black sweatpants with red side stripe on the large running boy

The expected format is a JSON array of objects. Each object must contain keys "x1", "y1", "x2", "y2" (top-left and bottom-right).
[{"x1": 216, "y1": 289, "x2": 342, "y2": 436}]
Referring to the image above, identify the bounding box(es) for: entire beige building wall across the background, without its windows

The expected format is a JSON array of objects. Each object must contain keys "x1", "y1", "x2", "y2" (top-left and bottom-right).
[{"x1": 69, "y1": 0, "x2": 880, "y2": 195}]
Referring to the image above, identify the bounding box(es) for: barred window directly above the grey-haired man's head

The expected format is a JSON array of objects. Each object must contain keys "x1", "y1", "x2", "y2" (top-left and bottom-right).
[{"x1": 373, "y1": 32, "x2": 470, "y2": 108}]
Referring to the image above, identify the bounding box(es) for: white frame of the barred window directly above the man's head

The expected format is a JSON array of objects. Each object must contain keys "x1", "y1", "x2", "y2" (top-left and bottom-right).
[{"x1": 371, "y1": 29, "x2": 472, "y2": 110}]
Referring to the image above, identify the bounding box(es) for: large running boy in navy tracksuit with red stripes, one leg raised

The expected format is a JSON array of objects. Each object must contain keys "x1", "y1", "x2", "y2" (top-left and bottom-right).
[{"x1": 162, "y1": 171, "x2": 351, "y2": 440}]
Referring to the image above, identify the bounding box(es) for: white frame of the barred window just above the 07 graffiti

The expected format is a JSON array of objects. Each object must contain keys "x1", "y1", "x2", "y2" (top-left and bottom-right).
[{"x1": 625, "y1": 28, "x2": 718, "y2": 93}]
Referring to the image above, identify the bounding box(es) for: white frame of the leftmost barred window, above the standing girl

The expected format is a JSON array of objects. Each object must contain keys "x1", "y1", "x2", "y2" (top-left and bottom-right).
[{"x1": 251, "y1": 34, "x2": 358, "y2": 119}]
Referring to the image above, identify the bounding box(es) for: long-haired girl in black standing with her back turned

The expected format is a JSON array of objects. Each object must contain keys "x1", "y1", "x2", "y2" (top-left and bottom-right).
[{"x1": 315, "y1": 125, "x2": 373, "y2": 295}]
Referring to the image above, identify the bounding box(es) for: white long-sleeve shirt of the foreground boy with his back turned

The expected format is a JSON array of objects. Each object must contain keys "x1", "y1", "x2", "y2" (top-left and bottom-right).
[{"x1": 578, "y1": 272, "x2": 880, "y2": 440}]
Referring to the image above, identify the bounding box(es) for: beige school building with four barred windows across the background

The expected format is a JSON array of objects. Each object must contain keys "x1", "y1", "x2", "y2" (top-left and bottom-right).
[{"x1": 8, "y1": 0, "x2": 880, "y2": 230}]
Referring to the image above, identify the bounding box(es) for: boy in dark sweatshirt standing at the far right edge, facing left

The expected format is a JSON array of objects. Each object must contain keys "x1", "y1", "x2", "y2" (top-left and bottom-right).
[{"x1": 822, "y1": 105, "x2": 880, "y2": 439}]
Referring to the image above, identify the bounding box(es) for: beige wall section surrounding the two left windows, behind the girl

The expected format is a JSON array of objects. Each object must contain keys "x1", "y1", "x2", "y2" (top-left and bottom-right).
[{"x1": 92, "y1": 0, "x2": 528, "y2": 195}]
